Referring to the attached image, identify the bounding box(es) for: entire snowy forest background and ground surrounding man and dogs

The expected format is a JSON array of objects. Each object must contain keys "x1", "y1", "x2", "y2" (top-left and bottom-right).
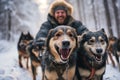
[{"x1": 0, "y1": 0, "x2": 120, "y2": 80}]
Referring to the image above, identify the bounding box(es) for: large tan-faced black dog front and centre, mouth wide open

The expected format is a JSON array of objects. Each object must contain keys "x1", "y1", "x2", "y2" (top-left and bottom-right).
[{"x1": 42, "y1": 25, "x2": 77, "y2": 80}]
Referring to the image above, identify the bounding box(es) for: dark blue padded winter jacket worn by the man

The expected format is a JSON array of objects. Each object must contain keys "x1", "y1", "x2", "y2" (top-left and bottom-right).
[{"x1": 35, "y1": 14, "x2": 88, "y2": 40}]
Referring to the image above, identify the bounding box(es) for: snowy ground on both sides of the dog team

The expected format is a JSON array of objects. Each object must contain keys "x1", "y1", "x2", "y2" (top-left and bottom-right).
[{"x1": 0, "y1": 41, "x2": 120, "y2": 80}]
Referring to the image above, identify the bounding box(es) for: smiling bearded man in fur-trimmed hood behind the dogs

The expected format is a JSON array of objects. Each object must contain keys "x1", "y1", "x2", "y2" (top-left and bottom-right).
[{"x1": 36, "y1": 0, "x2": 88, "y2": 41}]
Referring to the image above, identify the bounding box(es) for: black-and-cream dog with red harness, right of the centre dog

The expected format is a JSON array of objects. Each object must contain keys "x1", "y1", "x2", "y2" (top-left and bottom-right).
[{"x1": 76, "y1": 29, "x2": 108, "y2": 80}]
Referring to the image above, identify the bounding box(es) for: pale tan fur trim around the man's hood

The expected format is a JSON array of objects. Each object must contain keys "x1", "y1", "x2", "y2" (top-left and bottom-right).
[{"x1": 49, "y1": 0, "x2": 73, "y2": 16}]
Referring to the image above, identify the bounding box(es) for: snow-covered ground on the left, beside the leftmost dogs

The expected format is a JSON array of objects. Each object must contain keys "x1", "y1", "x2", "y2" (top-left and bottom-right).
[{"x1": 0, "y1": 41, "x2": 41, "y2": 80}]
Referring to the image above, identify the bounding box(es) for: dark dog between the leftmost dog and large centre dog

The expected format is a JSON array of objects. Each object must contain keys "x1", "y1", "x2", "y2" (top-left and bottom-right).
[{"x1": 26, "y1": 40, "x2": 45, "y2": 80}]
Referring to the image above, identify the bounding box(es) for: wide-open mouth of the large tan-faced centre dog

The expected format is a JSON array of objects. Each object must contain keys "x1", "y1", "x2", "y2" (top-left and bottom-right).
[{"x1": 55, "y1": 46, "x2": 71, "y2": 61}]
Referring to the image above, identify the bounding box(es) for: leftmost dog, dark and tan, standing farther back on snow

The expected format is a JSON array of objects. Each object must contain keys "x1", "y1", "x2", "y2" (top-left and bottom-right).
[{"x1": 17, "y1": 32, "x2": 33, "y2": 69}]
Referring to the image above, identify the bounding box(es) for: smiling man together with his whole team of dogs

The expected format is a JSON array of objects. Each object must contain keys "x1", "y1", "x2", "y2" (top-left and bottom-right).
[{"x1": 18, "y1": 0, "x2": 120, "y2": 80}]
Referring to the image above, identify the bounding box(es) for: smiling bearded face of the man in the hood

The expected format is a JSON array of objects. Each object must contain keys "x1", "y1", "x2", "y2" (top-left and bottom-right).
[{"x1": 54, "y1": 10, "x2": 67, "y2": 24}]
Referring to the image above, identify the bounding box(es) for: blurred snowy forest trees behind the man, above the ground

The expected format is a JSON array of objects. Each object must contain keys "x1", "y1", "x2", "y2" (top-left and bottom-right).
[{"x1": 0, "y1": 0, "x2": 120, "y2": 40}]
